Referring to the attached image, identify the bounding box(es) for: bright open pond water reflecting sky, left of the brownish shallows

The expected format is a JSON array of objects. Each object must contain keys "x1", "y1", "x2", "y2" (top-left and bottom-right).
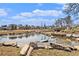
[{"x1": 0, "y1": 34, "x2": 48, "y2": 44}]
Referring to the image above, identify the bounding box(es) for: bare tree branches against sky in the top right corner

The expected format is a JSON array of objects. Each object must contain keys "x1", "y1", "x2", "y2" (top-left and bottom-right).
[{"x1": 64, "y1": 3, "x2": 79, "y2": 15}]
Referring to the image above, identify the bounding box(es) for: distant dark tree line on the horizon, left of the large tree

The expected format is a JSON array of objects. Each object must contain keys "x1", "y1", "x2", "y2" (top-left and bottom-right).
[{"x1": 0, "y1": 24, "x2": 52, "y2": 30}]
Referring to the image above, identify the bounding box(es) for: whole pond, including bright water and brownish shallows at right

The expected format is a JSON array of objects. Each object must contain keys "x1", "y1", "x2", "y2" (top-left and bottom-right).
[{"x1": 0, "y1": 33, "x2": 79, "y2": 46}]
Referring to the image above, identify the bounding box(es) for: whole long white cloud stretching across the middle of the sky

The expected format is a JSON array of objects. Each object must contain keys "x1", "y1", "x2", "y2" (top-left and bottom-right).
[{"x1": 12, "y1": 9, "x2": 63, "y2": 19}]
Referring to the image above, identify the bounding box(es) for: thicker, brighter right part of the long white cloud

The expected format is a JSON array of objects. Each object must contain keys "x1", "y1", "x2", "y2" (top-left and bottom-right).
[{"x1": 33, "y1": 9, "x2": 62, "y2": 17}]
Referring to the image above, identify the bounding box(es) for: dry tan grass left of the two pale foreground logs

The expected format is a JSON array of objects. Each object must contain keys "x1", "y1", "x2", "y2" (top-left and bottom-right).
[{"x1": 0, "y1": 46, "x2": 20, "y2": 56}]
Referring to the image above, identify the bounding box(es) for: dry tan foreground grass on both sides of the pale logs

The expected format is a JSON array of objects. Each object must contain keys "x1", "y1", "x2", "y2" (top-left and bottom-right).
[{"x1": 0, "y1": 46, "x2": 79, "y2": 56}]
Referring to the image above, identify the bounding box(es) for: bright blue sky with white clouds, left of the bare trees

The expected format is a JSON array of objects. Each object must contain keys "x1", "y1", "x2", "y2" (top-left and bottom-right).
[{"x1": 0, "y1": 3, "x2": 65, "y2": 26}]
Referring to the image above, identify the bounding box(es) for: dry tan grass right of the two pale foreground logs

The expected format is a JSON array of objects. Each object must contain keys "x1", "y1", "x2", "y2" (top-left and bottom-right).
[{"x1": 31, "y1": 49, "x2": 79, "y2": 56}]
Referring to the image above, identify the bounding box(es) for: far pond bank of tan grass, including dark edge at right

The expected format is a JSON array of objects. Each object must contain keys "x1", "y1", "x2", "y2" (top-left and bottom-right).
[{"x1": 0, "y1": 29, "x2": 79, "y2": 37}]
